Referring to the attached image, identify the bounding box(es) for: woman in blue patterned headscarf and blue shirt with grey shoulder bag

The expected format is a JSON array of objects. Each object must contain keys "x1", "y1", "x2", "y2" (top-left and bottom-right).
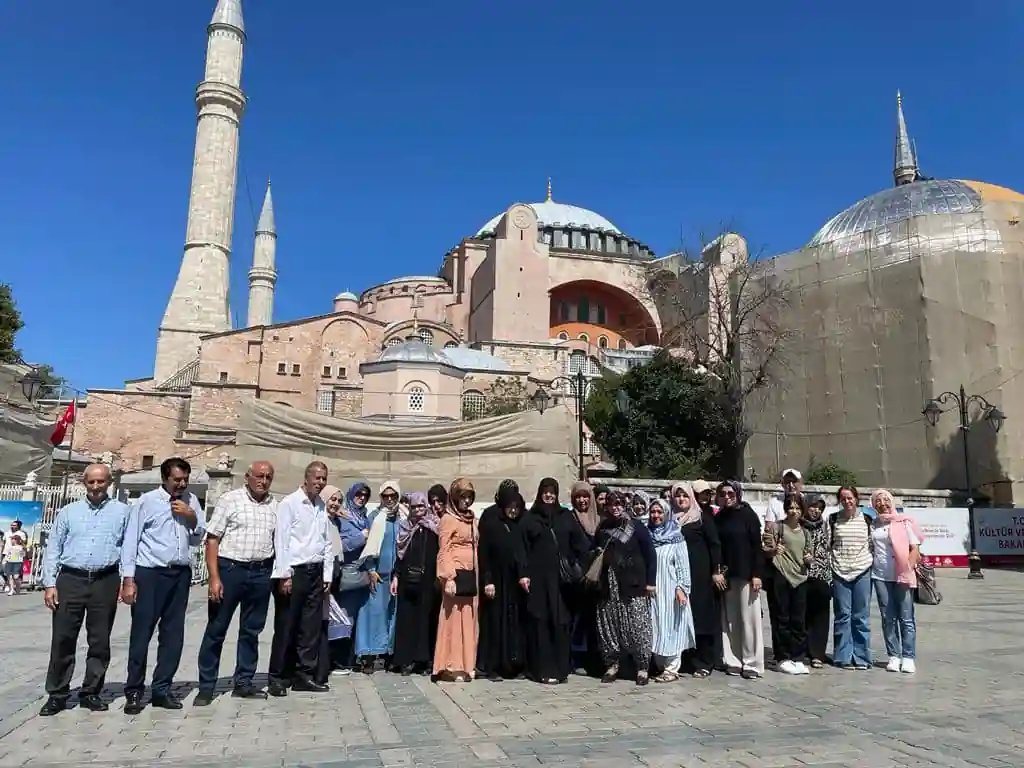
[{"x1": 325, "y1": 482, "x2": 370, "y2": 675}]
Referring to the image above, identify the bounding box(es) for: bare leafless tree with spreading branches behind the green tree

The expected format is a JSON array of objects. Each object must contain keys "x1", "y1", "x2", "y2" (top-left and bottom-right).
[{"x1": 641, "y1": 229, "x2": 794, "y2": 477}]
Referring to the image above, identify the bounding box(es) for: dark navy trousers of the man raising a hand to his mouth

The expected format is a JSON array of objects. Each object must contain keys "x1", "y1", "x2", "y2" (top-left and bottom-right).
[{"x1": 125, "y1": 565, "x2": 191, "y2": 696}]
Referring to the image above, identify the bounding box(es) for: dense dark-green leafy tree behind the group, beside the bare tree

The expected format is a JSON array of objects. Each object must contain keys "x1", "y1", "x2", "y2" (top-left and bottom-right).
[{"x1": 584, "y1": 352, "x2": 735, "y2": 477}]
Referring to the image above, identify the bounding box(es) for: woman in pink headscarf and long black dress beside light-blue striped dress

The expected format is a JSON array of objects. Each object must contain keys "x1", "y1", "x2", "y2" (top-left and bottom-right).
[{"x1": 669, "y1": 482, "x2": 725, "y2": 678}]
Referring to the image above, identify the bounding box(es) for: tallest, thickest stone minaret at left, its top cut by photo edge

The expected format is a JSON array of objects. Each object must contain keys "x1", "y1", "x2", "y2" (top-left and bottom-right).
[{"x1": 154, "y1": 0, "x2": 246, "y2": 384}]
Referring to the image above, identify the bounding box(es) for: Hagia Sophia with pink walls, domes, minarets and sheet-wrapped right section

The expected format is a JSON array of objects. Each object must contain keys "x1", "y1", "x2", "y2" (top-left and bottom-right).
[{"x1": 75, "y1": 0, "x2": 1024, "y2": 501}]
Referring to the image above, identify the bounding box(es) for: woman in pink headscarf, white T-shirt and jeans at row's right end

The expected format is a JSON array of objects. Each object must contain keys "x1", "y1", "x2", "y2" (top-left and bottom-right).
[{"x1": 871, "y1": 489, "x2": 924, "y2": 675}]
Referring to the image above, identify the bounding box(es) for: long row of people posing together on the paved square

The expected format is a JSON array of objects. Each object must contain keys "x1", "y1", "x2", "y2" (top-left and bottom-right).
[{"x1": 34, "y1": 459, "x2": 923, "y2": 716}]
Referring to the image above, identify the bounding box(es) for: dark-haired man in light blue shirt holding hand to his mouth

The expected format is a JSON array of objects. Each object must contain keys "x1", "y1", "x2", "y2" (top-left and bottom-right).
[{"x1": 121, "y1": 459, "x2": 204, "y2": 715}]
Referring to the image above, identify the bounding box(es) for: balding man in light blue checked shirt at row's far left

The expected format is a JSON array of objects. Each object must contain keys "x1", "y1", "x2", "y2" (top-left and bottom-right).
[{"x1": 39, "y1": 464, "x2": 128, "y2": 717}]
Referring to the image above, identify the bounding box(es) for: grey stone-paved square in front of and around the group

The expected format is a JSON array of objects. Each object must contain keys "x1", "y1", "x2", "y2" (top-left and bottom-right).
[{"x1": 0, "y1": 571, "x2": 1024, "y2": 768}]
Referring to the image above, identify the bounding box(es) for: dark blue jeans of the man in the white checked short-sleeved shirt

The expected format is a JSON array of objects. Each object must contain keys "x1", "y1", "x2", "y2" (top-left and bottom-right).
[{"x1": 199, "y1": 557, "x2": 273, "y2": 691}]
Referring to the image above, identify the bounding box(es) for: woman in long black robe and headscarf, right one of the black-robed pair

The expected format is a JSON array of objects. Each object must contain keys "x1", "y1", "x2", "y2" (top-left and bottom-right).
[{"x1": 517, "y1": 477, "x2": 590, "y2": 685}]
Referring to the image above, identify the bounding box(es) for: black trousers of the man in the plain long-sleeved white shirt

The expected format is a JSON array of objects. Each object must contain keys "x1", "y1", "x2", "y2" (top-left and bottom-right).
[{"x1": 268, "y1": 562, "x2": 324, "y2": 683}]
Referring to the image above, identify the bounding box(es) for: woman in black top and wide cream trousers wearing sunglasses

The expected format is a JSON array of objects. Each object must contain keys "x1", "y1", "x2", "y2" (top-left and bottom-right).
[{"x1": 715, "y1": 480, "x2": 765, "y2": 680}]
